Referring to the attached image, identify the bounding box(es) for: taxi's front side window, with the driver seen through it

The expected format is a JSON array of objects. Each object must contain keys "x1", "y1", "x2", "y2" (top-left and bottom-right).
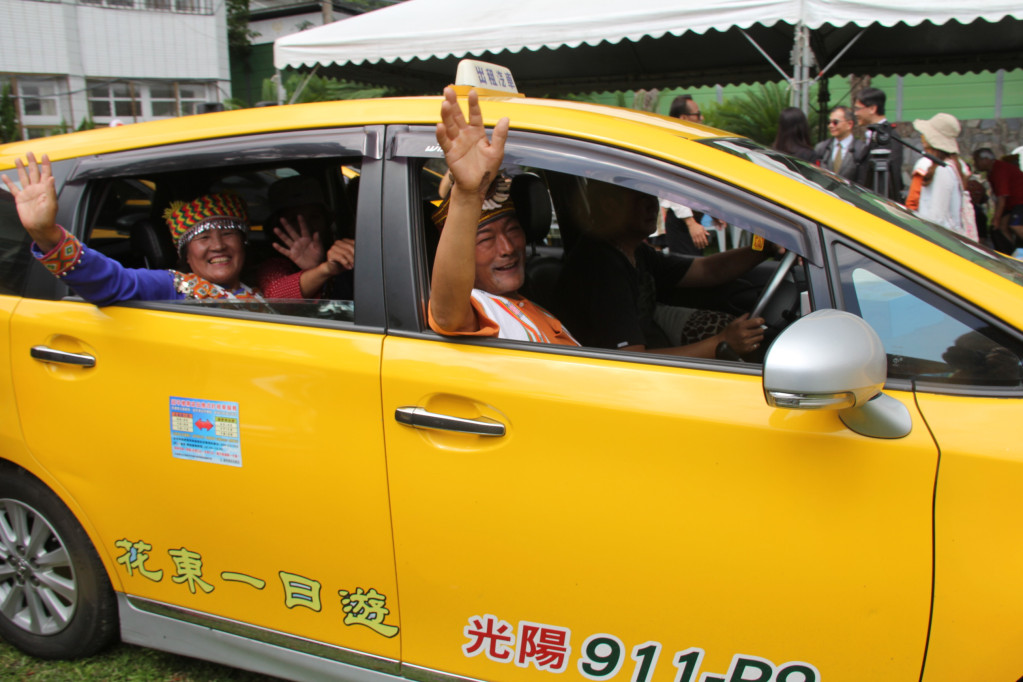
[{"x1": 405, "y1": 134, "x2": 816, "y2": 369}]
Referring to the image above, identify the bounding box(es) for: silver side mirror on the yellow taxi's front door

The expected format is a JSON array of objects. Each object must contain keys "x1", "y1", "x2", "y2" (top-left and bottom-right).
[{"x1": 763, "y1": 309, "x2": 913, "y2": 439}]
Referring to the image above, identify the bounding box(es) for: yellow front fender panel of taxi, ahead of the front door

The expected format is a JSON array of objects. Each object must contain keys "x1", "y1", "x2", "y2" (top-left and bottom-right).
[{"x1": 918, "y1": 394, "x2": 1023, "y2": 680}]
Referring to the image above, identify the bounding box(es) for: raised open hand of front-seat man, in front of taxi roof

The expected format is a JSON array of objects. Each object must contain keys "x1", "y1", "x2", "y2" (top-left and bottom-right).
[{"x1": 437, "y1": 86, "x2": 508, "y2": 196}]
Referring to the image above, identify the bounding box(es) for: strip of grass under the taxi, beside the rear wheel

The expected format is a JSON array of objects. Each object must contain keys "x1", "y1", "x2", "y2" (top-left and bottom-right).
[{"x1": 0, "y1": 639, "x2": 277, "y2": 682}]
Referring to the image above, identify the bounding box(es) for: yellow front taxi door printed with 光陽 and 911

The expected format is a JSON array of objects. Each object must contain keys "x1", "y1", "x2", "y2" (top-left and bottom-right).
[{"x1": 382, "y1": 127, "x2": 937, "y2": 682}]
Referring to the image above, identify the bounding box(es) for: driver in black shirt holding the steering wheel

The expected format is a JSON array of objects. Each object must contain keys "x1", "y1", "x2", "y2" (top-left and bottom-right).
[{"x1": 554, "y1": 179, "x2": 768, "y2": 359}]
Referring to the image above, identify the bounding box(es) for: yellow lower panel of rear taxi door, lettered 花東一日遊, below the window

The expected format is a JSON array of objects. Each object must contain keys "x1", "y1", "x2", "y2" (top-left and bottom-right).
[{"x1": 11, "y1": 301, "x2": 399, "y2": 658}]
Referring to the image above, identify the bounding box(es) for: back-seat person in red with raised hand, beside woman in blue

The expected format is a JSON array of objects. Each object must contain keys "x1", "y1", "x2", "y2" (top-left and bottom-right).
[{"x1": 257, "y1": 175, "x2": 355, "y2": 300}]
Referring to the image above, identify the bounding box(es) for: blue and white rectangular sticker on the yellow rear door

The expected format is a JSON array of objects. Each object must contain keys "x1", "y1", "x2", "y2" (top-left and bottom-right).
[{"x1": 171, "y1": 397, "x2": 241, "y2": 466}]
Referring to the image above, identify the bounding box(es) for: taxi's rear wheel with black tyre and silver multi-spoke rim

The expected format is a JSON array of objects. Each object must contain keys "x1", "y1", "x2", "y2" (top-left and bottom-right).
[{"x1": 0, "y1": 466, "x2": 120, "y2": 658}]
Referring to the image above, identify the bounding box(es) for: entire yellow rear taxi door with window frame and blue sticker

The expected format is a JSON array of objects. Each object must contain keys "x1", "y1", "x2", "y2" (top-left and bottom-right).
[{"x1": 11, "y1": 129, "x2": 400, "y2": 668}]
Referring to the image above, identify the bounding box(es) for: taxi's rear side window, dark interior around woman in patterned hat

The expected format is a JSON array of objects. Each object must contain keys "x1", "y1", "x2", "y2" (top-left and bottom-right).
[{"x1": 78, "y1": 157, "x2": 361, "y2": 322}]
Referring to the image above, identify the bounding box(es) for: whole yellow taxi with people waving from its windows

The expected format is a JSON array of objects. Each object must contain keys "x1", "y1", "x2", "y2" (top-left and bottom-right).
[{"x1": 0, "y1": 63, "x2": 1023, "y2": 682}]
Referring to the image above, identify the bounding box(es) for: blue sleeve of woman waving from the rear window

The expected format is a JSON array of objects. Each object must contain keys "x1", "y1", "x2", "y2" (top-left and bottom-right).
[{"x1": 32, "y1": 244, "x2": 185, "y2": 306}]
